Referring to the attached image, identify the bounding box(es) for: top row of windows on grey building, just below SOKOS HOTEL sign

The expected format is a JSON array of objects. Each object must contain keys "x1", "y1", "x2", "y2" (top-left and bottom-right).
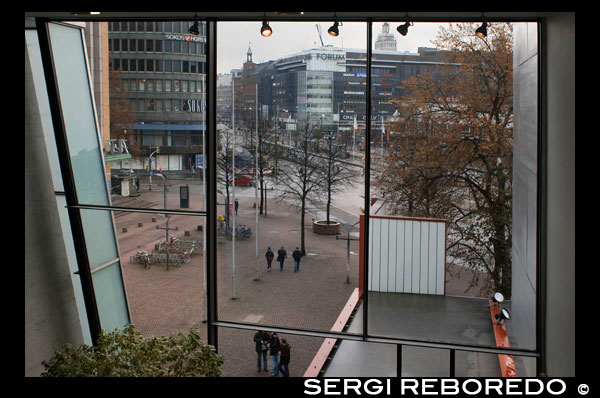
[{"x1": 108, "y1": 38, "x2": 206, "y2": 55}]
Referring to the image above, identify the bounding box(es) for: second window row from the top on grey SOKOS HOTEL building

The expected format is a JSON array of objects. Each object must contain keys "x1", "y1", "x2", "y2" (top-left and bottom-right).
[{"x1": 109, "y1": 58, "x2": 206, "y2": 74}]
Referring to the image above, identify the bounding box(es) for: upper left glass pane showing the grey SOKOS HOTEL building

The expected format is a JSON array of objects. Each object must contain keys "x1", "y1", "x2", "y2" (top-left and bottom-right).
[{"x1": 104, "y1": 22, "x2": 206, "y2": 209}]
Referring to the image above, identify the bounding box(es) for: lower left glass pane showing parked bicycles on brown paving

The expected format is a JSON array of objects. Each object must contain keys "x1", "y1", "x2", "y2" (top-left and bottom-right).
[{"x1": 114, "y1": 208, "x2": 206, "y2": 336}]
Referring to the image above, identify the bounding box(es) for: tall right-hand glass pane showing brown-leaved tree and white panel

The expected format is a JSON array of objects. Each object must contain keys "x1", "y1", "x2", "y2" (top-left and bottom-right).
[{"x1": 366, "y1": 21, "x2": 537, "y2": 348}]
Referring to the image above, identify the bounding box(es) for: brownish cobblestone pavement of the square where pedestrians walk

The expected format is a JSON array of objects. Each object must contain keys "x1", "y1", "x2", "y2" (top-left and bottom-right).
[{"x1": 115, "y1": 182, "x2": 358, "y2": 377}]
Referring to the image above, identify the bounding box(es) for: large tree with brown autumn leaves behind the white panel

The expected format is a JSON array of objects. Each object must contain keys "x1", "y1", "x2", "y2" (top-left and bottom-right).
[{"x1": 378, "y1": 23, "x2": 513, "y2": 297}]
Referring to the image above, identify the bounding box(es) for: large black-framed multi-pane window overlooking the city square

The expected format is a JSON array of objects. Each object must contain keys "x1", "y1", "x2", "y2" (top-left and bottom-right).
[{"x1": 39, "y1": 15, "x2": 539, "y2": 376}]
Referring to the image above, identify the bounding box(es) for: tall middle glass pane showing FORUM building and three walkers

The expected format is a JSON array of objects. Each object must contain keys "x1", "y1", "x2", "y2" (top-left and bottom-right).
[{"x1": 217, "y1": 21, "x2": 366, "y2": 331}]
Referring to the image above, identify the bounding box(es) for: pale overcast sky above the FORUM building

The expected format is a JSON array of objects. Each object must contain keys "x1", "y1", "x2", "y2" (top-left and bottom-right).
[{"x1": 217, "y1": 21, "x2": 446, "y2": 73}]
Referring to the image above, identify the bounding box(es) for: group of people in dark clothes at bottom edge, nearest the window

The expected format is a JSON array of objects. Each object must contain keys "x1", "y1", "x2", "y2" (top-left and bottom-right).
[{"x1": 254, "y1": 330, "x2": 291, "y2": 377}]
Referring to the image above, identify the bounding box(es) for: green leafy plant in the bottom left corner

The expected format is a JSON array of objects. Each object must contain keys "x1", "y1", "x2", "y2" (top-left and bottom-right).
[{"x1": 41, "y1": 325, "x2": 223, "y2": 377}]
